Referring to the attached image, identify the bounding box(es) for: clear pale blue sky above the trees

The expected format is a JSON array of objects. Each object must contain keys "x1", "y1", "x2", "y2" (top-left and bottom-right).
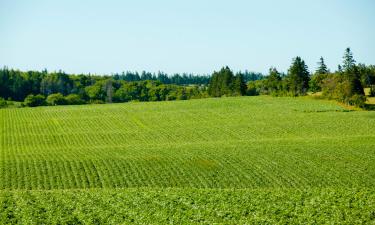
[{"x1": 0, "y1": 0, "x2": 375, "y2": 74}]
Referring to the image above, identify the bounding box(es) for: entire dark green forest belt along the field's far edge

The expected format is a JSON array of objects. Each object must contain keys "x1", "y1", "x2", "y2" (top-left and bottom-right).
[{"x1": 0, "y1": 48, "x2": 375, "y2": 107}]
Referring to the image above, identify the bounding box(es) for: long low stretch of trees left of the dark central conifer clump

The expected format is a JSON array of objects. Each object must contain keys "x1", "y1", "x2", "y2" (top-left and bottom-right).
[{"x1": 0, "y1": 67, "x2": 264, "y2": 107}]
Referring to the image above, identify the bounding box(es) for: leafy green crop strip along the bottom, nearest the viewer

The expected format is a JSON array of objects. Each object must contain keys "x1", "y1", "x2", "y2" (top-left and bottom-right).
[{"x1": 0, "y1": 188, "x2": 375, "y2": 224}]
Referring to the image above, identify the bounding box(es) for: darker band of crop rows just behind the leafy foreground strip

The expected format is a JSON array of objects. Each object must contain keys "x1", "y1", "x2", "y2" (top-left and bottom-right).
[{"x1": 0, "y1": 139, "x2": 375, "y2": 189}]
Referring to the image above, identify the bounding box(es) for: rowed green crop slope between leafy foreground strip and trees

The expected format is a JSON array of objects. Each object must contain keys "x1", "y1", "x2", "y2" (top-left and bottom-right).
[{"x1": 0, "y1": 97, "x2": 375, "y2": 190}]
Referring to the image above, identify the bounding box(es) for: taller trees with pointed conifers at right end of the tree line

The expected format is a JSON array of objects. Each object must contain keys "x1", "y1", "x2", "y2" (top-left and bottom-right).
[{"x1": 247, "y1": 48, "x2": 375, "y2": 107}]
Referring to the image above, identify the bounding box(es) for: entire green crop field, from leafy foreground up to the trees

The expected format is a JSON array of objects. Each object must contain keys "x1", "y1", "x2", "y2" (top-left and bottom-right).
[{"x1": 0, "y1": 96, "x2": 375, "y2": 224}]
